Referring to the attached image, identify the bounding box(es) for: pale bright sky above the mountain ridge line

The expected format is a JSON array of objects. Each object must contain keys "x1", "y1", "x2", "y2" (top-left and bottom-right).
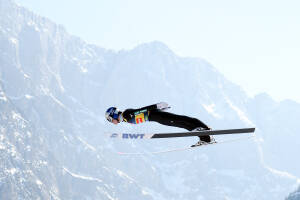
[{"x1": 15, "y1": 0, "x2": 300, "y2": 103}]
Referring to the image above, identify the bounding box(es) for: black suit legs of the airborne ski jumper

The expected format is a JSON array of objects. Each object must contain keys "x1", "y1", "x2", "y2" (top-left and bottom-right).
[{"x1": 149, "y1": 110, "x2": 210, "y2": 142}]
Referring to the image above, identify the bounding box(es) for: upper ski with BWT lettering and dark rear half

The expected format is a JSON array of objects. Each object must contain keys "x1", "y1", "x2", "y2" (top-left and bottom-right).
[{"x1": 109, "y1": 128, "x2": 255, "y2": 139}]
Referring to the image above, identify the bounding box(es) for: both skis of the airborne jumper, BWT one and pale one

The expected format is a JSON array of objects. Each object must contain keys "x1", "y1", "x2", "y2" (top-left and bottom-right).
[{"x1": 110, "y1": 128, "x2": 255, "y2": 155}]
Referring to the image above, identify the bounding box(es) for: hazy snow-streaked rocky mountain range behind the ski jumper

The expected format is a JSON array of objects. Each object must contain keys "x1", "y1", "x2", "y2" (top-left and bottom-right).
[{"x1": 0, "y1": 0, "x2": 300, "y2": 200}]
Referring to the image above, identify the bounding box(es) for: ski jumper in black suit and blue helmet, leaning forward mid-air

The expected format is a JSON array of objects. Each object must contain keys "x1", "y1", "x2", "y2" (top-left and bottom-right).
[{"x1": 105, "y1": 102, "x2": 215, "y2": 147}]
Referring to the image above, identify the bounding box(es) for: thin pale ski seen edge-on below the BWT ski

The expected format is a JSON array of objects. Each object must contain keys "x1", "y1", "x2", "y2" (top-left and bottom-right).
[{"x1": 117, "y1": 135, "x2": 254, "y2": 156}]
